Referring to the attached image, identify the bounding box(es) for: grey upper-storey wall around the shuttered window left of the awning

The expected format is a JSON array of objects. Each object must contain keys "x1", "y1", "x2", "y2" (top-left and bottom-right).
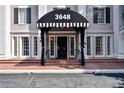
[{"x1": 11, "y1": 5, "x2": 38, "y2": 32}]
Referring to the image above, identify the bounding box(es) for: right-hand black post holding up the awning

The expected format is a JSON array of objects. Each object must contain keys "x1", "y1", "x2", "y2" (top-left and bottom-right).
[{"x1": 80, "y1": 29, "x2": 85, "y2": 66}]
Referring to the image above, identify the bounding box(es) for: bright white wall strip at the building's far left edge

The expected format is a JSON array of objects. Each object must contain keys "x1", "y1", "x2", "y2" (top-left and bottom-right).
[{"x1": 0, "y1": 5, "x2": 11, "y2": 58}]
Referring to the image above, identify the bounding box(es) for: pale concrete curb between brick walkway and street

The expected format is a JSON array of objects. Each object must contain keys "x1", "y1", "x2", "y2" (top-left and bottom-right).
[{"x1": 0, "y1": 69, "x2": 124, "y2": 74}]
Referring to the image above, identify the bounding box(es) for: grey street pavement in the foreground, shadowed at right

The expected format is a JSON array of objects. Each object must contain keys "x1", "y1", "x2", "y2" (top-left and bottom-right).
[{"x1": 0, "y1": 73, "x2": 124, "y2": 88}]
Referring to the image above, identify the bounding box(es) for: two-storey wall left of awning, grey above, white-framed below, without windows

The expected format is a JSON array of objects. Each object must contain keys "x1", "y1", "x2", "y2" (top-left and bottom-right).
[{"x1": 11, "y1": 5, "x2": 40, "y2": 58}]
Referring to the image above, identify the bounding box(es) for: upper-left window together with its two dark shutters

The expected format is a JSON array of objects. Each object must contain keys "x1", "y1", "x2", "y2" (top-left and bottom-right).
[{"x1": 14, "y1": 8, "x2": 31, "y2": 24}]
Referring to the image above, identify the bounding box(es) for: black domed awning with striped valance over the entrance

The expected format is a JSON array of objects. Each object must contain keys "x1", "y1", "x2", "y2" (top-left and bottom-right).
[{"x1": 37, "y1": 9, "x2": 89, "y2": 28}]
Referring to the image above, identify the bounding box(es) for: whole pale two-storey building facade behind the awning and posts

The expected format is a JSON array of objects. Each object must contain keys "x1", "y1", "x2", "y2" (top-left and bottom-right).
[{"x1": 0, "y1": 5, "x2": 124, "y2": 59}]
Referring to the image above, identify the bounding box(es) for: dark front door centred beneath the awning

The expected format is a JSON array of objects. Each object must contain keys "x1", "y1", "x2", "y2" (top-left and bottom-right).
[{"x1": 57, "y1": 37, "x2": 67, "y2": 59}]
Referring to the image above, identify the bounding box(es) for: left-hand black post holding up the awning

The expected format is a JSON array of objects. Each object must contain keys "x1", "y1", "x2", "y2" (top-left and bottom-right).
[{"x1": 41, "y1": 29, "x2": 45, "y2": 66}]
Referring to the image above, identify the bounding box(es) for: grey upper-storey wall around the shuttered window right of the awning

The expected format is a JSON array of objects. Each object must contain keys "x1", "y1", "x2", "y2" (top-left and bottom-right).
[{"x1": 86, "y1": 5, "x2": 113, "y2": 32}]
